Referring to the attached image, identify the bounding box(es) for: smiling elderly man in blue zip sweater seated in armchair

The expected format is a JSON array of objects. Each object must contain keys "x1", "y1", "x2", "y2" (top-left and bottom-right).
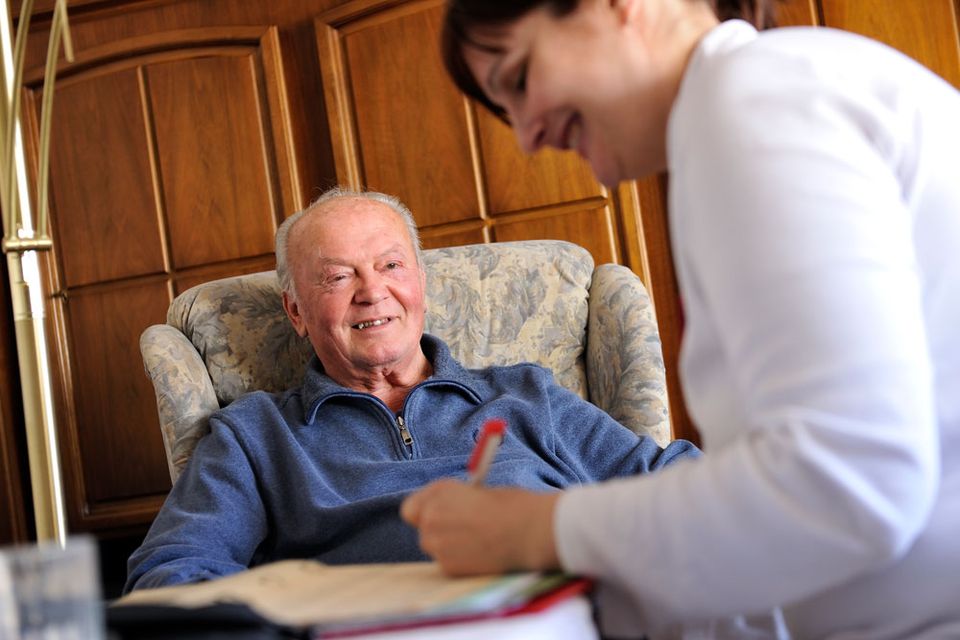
[{"x1": 125, "y1": 189, "x2": 698, "y2": 591}]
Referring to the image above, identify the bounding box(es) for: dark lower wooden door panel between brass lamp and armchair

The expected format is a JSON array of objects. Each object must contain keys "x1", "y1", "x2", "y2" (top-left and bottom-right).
[{"x1": 59, "y1": 279, "x2": 170, "y2": 529}]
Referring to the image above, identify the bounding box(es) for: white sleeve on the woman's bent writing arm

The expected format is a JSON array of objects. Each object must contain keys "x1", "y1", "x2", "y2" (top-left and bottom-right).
[{"x1": 555, "y1": 47, "x2": 939, "y2": 630}]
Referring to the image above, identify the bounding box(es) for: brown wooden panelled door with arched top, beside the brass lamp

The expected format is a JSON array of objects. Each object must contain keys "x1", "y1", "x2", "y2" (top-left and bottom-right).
[{"x1": 28, "y1": 26, "x2": 302, "y2": 531}]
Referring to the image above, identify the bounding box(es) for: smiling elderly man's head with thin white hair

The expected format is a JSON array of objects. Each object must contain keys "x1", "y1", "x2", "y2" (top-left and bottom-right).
[{"x1": 283, "y1": 197, "x2": 426, "y2": 386}]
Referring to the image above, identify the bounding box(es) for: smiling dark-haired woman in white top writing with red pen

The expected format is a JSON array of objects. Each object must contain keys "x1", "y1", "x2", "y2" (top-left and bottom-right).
[{"x1": 402, "y1": 0, "x2": 960, "y2": 640}]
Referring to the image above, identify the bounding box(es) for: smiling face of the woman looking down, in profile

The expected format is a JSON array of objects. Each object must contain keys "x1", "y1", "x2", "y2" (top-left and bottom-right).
[{"x1": 464, "y1": 0, "x2": 712, "y2": 186}]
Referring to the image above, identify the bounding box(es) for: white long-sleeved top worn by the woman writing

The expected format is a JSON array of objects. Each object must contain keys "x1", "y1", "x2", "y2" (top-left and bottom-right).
[{"x1": 555, "y1": 21, "x2": 960, "y2": 640}]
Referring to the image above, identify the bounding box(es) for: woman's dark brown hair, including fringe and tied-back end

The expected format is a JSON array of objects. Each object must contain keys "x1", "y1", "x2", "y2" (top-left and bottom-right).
[{"x1": 440, "y1": 0, "x2": 776, "y2": 121}]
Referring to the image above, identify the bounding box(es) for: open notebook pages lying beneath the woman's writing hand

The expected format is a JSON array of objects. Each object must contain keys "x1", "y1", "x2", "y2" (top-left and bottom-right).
[{"x1": 113, "y1": 560, "x2": 590, "y2": 637}]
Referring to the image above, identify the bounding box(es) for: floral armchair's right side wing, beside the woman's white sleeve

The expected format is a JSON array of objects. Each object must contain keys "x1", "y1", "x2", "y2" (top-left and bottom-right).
[{"x1": 586, "y1": 264, "x2": 671, "y2": 446}]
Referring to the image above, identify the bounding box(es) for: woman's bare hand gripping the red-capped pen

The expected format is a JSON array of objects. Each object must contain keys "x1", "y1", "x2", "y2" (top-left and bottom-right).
[{"x1": 400, "y1": 480, "x2": 560, "y2": 575}]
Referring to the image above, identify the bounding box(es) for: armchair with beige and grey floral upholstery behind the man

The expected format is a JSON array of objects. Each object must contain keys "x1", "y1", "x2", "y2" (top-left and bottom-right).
[{"x1": 140, "y1": 240, "x2": 670, "y2": 480}]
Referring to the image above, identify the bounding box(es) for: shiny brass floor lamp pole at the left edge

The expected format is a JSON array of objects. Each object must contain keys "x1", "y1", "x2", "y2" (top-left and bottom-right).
[{"x1": 0, "y1": 0, "x2": 73, "y2": 546}]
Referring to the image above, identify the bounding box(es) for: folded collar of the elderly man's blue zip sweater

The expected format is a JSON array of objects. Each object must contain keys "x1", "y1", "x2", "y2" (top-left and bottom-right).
[{"x1": 301, "y1": 333, "x2": 485, "y2": 422}]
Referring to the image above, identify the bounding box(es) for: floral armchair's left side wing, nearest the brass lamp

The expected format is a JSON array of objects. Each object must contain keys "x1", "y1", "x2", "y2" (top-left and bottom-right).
[{"x1": 140, "y1": 324, "x2": 220, "y2": 482}]
